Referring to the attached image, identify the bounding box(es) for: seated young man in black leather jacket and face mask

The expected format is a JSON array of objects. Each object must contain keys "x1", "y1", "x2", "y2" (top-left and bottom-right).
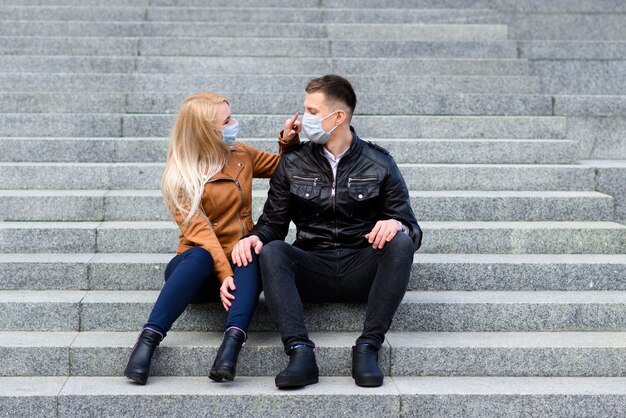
[{"x1": 232, "y1": 75, "x2": 422, "y2": 388}]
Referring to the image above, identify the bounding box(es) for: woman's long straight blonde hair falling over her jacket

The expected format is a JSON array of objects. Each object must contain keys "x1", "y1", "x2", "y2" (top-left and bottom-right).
[{"x1": 161, "y1": 92, "x2": 230, "y2": 225}]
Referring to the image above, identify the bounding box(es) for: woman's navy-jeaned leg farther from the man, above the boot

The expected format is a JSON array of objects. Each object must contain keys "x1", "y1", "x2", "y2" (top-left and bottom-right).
[{"x1": 144, "y1": 247, "x2": 219, "y2": 336}]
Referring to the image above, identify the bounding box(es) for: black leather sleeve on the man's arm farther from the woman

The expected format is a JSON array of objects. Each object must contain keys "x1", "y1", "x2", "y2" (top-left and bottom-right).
[{"x1": 381, "y1": 157, "x2": 422, "y2": 251}]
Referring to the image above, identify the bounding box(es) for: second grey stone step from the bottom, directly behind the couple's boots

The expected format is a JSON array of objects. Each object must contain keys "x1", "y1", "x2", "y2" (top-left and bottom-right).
[{"x1": 0, "y1": 332, "x2": 626, "y2": 377}]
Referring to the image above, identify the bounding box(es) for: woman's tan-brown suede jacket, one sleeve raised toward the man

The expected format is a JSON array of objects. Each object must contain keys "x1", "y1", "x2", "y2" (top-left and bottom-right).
[{"x1": 174, "y1": 139, "x2": 299, "y2": 282}]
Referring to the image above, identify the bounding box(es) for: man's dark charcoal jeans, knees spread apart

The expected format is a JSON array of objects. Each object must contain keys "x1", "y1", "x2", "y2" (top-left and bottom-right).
[{"x1": 260, "y1": 233, "x2": 414, "y2": 348}]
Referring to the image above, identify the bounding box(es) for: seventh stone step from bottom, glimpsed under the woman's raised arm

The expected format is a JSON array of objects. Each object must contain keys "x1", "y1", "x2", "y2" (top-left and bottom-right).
[{"x1": 0, "y1": 163, "x2": 595, "y2": 191}]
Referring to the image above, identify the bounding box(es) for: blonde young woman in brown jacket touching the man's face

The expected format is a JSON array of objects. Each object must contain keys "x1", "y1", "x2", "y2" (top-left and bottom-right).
[{"x1": 124, "y1": 93, "x2": 300, "y2": 385}]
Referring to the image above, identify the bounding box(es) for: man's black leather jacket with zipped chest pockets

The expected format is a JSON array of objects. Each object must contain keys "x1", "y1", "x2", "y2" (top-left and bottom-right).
[{"x1": 249, "y1": 128, "x2": 422, "y2": 250}]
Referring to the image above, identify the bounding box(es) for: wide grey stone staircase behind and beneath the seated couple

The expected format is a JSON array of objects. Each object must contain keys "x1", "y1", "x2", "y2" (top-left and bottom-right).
[{"x1": 0, "y1": 0, "x2": 626, "y2": 417}]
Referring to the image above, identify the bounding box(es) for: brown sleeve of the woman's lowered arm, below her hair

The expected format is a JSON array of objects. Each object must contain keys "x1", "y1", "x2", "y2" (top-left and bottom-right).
[{"x1": 174, "y1": 210, "x2": 234, "y2": 283}]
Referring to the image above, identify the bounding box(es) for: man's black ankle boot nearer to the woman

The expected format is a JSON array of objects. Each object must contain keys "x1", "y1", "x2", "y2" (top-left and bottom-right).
[{"x1": 275, "y1": 344, "x2": 320, "y2": 388}]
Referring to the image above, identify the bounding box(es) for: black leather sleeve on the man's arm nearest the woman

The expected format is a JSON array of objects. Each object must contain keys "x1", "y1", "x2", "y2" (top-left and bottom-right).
[{"x1": 248, "y1": 159, "x2": 291, "y2": 244}]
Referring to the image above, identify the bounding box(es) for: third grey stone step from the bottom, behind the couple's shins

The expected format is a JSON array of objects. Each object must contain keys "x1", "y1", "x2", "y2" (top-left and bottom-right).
[{"x1": 0, "y1": 290, "x2": 626, "y2": 332}]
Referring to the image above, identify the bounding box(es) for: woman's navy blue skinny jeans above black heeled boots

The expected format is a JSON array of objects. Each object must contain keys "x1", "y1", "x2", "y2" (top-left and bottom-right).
[{"x1": 144, "y1": 247, "x2": 262, "y2": 335}]
